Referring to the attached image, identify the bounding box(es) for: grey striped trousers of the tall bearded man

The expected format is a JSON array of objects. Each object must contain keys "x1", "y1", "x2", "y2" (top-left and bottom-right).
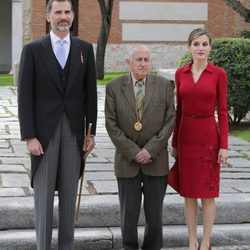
[{"x1": 34, "y1": 114, "x2": 81, "y2": 250}]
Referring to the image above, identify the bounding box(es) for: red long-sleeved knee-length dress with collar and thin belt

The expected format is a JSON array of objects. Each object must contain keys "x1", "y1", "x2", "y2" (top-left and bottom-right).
[{"x1": 172, "y1": 63, "x2": 228, "y2": 198}]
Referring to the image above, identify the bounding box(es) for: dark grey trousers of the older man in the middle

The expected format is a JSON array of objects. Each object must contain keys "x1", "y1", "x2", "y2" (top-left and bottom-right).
[{"x1": 117, "y1": 172, "x2": 167, "y2": 250}]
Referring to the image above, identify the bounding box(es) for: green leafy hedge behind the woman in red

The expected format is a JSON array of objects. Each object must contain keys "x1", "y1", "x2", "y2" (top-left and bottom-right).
[{"x1": 179, "y1": 38, "x2": 250, "y2": 124}]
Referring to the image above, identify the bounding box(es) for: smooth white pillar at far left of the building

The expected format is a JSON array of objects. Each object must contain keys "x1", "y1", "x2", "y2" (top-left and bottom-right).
[{"x1": 12, "y1": 0, "x2": 23, "y2": 69}]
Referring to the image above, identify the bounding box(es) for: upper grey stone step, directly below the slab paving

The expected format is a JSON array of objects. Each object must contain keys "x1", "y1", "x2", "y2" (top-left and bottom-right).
[{"x1": 0, "y1": 193, "x2": 250, "y2": 230}]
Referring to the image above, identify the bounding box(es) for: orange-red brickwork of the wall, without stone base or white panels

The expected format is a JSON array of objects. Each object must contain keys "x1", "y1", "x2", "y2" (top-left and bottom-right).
[{"x1": 32, "y1": 0, "x2": 250, "y2": 43}]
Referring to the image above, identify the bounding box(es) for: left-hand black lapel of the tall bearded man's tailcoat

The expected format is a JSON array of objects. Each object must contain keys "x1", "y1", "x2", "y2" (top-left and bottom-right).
[{"x1": 41, "y1": 34, "x2": 63, "y2": 93}]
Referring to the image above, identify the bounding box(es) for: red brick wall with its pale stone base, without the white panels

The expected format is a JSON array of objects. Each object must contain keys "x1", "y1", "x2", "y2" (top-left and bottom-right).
[{"x1": 32, "y1": 0, "x2": 250, "y2": 71}]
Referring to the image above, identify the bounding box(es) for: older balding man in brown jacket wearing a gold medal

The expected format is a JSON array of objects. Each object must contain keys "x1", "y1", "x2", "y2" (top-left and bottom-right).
[{"x1": 105, "y1": 45, "x2": 175, "y2": 250}]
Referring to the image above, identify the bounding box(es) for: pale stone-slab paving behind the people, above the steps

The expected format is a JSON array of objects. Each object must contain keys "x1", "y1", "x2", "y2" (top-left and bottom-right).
[{"x1": 0, "y1": 87, "x2": 250, "y2": 250}]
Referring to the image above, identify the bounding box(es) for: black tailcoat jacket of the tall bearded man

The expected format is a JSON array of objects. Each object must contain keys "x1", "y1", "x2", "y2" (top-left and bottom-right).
[{"x1": 18, "y1": 35, "x2": 97, "y2": 186}]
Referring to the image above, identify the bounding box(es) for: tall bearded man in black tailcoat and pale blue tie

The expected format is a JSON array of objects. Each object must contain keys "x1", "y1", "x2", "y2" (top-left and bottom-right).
[{"x1": 18, "y1": 0, "x2": 97, "y2": 250}]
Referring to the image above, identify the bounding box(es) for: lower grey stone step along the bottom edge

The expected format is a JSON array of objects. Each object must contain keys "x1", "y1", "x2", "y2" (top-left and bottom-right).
[{"x1": 0, "y1": 223, "x2": 250, "y2": 250}]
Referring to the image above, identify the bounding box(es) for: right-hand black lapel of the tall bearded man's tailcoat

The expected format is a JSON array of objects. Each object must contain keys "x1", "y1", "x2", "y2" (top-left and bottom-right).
[{"x1": 66, "y1": 36, "x2": 81, "y2": 95}]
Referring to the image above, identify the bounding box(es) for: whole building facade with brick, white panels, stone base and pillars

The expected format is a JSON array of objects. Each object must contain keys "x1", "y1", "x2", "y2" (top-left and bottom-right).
[{"x1": 0, "y1": 0, "x2": 250, "y2": 72}]
